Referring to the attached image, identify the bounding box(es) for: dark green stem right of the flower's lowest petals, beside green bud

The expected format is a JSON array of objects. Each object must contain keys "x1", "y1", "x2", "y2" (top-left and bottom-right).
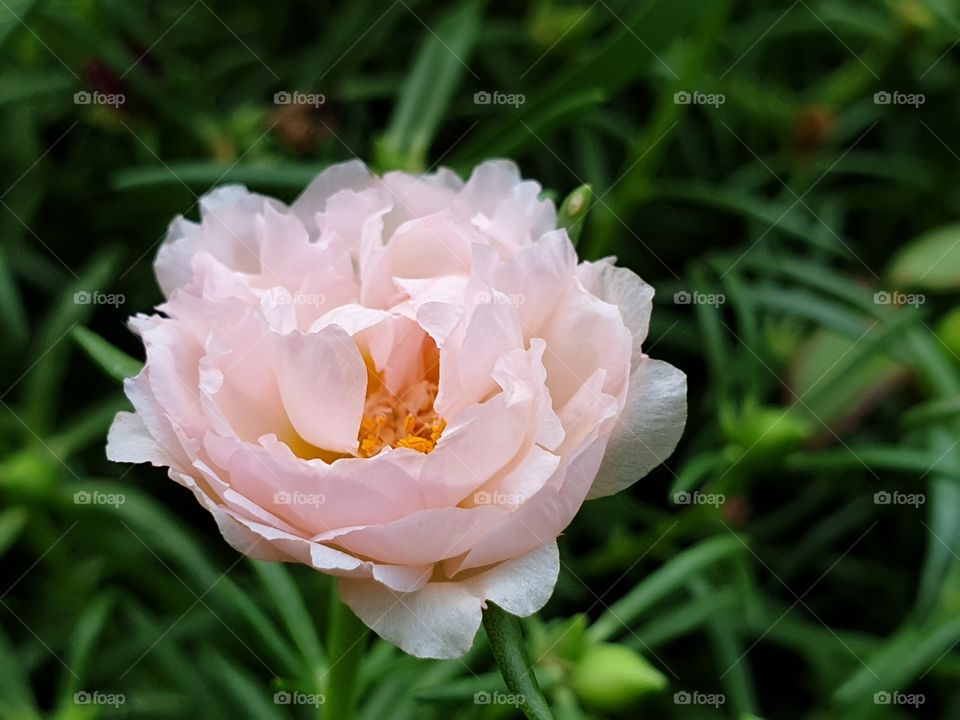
[{"x1": 483, "y1": 602, "x2": 554, "y2": 720}]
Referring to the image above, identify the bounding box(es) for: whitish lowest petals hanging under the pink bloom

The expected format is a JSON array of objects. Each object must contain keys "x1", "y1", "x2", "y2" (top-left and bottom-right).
[{"x1": 337, "y1": 540, "x2": 560, "y2": 659}]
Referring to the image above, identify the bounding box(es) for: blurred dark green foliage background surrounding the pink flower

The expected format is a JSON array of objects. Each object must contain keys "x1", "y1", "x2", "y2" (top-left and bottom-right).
[{"x1": 0, "y1": 0, "x2": 960, "y2": 720}]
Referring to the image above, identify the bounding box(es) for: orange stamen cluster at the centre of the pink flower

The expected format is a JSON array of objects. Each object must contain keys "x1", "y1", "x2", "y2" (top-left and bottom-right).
[{"x1": 357, "y1": 339, "x2": 447, "y2": 458}]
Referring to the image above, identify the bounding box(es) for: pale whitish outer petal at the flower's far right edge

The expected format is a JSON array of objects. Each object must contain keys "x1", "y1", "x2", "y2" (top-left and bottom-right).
[{"x1": 587, "y1": 358, "x2": 687, "y2": 500}]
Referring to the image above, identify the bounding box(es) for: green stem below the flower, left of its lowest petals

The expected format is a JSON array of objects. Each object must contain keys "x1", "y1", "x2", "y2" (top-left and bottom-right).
[{"x1": 320, "y1": 585, "x2": 367, "y2": 720}]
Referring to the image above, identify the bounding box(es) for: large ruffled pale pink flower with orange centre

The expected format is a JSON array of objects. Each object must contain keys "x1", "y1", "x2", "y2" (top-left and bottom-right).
[{"x1": 107, "y1": 161, "x2": 686, "y2": 657}]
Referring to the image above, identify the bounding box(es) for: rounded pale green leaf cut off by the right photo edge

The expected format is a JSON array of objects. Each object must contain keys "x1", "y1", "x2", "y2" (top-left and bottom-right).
[{"x1": 887, "y1": 223, "x2": 960, "y2": 290}]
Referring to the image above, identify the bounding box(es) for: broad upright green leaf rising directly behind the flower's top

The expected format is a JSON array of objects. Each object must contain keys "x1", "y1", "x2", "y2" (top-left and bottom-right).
[{"x1": 376, "y1": 0, "x2": 481, "y2": 171}]
